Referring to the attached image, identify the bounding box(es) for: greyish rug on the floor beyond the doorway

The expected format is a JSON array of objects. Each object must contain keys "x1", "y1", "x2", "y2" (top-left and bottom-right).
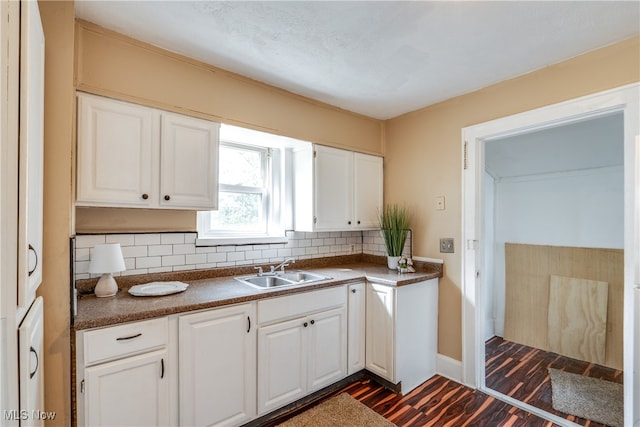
[{"x1": 549, "y1": 368, "x2": 624, "y2": 427}]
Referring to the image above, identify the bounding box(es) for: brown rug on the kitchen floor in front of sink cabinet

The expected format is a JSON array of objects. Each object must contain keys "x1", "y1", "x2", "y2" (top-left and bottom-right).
[{"x1": 280, "y1": 393, "x2": 395, "y2": 427}]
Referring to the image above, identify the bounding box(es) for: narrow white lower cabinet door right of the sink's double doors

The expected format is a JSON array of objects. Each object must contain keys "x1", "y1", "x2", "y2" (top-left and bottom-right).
[{"x1": 347, "y1": 283, "x2": 366, "y2": 375}]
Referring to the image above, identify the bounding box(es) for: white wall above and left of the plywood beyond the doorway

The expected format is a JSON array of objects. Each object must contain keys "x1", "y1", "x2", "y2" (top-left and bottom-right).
[{"x1": 485, "y1": 167, "x2": 624, "y2": 336}]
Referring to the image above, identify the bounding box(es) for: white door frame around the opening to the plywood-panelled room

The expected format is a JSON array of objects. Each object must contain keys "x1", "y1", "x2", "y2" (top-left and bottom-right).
[{"x1": 462, "y1": 83, "x2": 640, "y2": 425}]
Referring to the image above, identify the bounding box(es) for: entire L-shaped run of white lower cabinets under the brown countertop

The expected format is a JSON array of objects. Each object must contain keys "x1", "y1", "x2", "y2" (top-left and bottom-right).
[{"x1": 76, "y1": 279, "x2": 438, "y2": 426}]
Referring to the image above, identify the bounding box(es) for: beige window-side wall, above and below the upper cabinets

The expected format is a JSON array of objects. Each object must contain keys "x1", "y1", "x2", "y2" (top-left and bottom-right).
[{"x1": 76, "y1": 21, "x2": 384, "y2": 232}]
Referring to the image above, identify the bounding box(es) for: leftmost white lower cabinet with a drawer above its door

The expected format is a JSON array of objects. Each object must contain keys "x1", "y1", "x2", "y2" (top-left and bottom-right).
[{"x1": 76, "y1": 318, "x2": 172, "y2": 426}]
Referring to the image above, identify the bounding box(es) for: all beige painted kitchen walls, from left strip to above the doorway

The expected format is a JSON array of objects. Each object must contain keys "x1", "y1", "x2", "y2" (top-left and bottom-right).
[{"x1": 40, "y1": 4, "x2": 640, "y2": 425}]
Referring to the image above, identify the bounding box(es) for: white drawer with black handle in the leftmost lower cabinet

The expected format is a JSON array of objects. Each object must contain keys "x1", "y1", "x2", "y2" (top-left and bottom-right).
[{"x1": 79, "y1": 317, "x2": 169, "y2": 366}]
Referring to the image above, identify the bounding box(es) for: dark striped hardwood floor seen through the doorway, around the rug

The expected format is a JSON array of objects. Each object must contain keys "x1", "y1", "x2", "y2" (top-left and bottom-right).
[{"x1": 485, "y1": 337, "x2": 623, "y2": 427}]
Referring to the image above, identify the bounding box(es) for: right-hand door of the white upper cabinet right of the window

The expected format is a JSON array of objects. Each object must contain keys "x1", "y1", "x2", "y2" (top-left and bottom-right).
[{"x1": 353, "y1": 153, "x2": 382, "y2": 228}]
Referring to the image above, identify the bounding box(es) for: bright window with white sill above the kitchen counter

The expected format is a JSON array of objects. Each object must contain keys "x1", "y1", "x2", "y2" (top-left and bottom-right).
[{"x1": 197, "y1": 125, "x2": 302, "y2": 246}]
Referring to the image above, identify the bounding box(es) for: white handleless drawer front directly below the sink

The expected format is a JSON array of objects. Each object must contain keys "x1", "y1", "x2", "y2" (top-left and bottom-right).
[{"x1": 258, "y1": 285, "x2": 347, "y2": 324}]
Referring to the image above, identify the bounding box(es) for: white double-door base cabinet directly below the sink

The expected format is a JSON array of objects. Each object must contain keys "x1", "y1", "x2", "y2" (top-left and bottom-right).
[{"x1": 258, "y1": 286, "x2": 347, "y2": 415}]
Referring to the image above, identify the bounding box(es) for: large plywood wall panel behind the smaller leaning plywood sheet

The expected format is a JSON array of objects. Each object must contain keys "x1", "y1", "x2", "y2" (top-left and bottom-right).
[{"x1": 504, "y1": 243, "x2": 624, "y2": 369}]
